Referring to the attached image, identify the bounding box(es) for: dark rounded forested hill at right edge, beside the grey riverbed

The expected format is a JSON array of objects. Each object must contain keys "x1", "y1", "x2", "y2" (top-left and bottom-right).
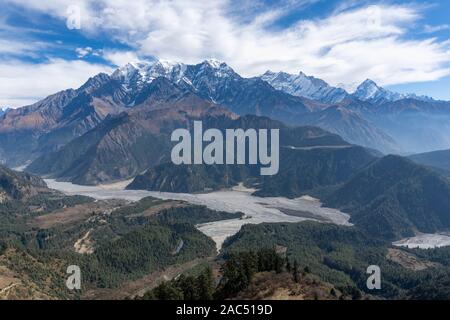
[{"x1": 324, "y1": 156, "x2": 450, "y2": 239}]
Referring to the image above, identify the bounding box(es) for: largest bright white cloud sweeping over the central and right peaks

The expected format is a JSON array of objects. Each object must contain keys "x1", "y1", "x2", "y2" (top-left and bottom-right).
[{"x1": 2, "y1": 0, "x2": 450, "y2": 90}]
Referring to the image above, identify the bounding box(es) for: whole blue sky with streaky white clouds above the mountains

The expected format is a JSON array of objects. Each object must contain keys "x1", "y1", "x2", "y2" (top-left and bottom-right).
[{"x1": 0, "y1": 0, "x2": 450, "y2": 107}]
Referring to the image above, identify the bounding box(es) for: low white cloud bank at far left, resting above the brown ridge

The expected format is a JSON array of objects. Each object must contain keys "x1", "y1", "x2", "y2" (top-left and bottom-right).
[{"x1": 0, "y1": 59, "x2": 112, "y2": 108}]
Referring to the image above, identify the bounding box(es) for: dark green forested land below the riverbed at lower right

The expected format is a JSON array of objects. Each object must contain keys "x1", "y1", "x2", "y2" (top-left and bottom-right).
[{"x1": 224, "y1": 222, "x2": 450, "y2": 299}]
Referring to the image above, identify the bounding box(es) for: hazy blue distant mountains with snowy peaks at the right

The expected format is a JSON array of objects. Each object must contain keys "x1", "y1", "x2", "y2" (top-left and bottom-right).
[{"x1": 260, "y1": 71, "x2": 450, "y2": 154}]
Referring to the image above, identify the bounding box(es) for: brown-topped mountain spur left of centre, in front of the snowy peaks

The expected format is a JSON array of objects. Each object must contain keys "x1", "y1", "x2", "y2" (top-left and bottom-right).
[{"x1": 27, "y1": 78, "x2": 234, "y2": 184}]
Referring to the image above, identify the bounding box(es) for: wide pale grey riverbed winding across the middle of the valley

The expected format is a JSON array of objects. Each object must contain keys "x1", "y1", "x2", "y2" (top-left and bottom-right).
[{"x1": 45, "y1": 179, "x2": 351, "y2": 250}]
